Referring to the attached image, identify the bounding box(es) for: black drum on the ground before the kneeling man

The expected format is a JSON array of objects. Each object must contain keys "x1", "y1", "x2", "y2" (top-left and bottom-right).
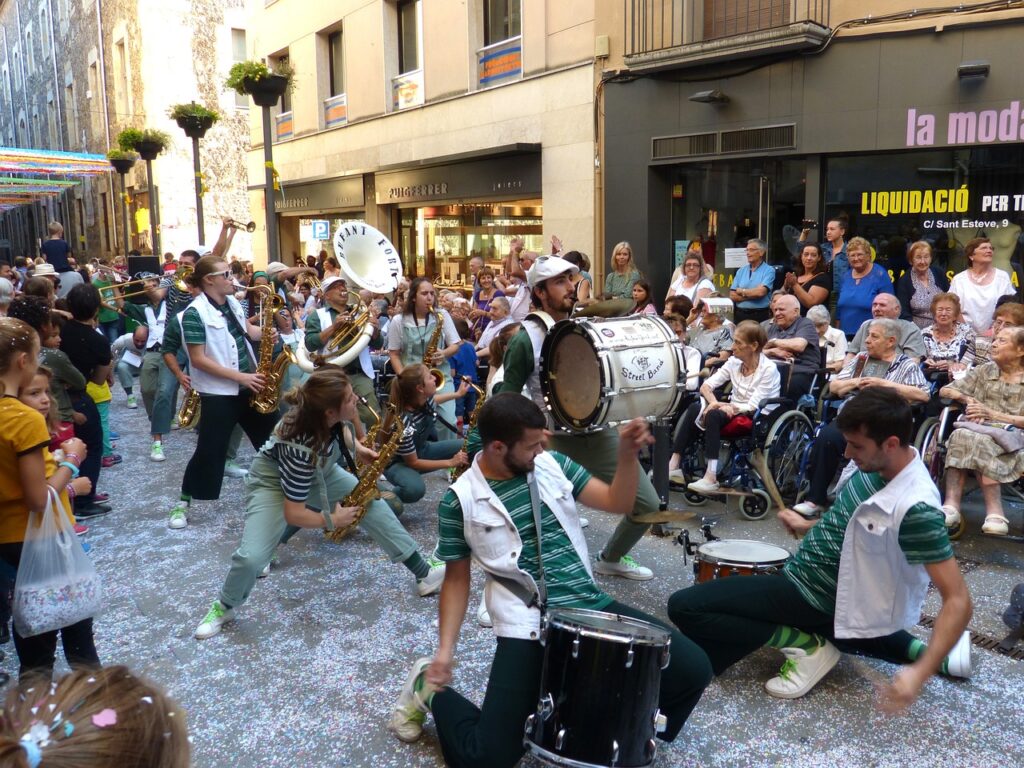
[{"x1": 523, "y1": 608, "x2": 670, "y2": 768}]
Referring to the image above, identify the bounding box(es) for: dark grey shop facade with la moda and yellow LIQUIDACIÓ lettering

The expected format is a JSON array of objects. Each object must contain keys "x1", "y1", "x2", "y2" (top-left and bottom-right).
[{"x1": 599, "y1": 0, "x2": 1024, "y2": 296}]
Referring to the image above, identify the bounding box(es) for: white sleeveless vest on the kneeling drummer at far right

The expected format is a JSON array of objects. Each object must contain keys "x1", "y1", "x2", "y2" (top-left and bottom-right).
[{"x1": 836, "y1": 451, "x2": 942, "y2": 638}]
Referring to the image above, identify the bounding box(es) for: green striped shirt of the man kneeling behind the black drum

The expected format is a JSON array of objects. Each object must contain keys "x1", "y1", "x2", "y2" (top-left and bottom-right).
[{"x1": 437, "y1": 453, "x2": 612, "y2": 610}]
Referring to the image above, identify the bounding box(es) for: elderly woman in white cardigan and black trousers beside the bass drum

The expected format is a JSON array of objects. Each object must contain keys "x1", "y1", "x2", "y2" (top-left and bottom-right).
[{"x1": 669, "y1": 321, "x2": 779, "y2": 505}]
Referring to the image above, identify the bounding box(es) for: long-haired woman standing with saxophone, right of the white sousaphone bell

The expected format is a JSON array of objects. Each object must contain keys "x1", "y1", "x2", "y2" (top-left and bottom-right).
[{"x1": 387, "y1": 278, "x2": 462, "y2": 440}]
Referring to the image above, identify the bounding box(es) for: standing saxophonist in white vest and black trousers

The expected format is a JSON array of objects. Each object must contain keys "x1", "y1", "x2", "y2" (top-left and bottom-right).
[{"x1": 167, "y1": 256, "x2": 278, "y2": 528}]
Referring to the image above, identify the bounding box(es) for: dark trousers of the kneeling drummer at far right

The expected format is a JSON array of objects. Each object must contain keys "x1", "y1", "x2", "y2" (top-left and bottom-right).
[{"x1": 669, "y1": 573, "x2": 913, "y2": 675}]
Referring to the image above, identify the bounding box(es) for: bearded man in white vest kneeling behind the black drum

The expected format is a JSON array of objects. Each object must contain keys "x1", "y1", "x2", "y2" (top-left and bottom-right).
[{"x1": 389, "y1": 392, "x2": 712, "y2": 768}]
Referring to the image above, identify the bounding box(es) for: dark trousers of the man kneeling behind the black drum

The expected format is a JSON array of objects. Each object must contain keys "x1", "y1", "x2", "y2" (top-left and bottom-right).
[{"x1": 430, "y1": 602, "x2": 712, "y2": 768}]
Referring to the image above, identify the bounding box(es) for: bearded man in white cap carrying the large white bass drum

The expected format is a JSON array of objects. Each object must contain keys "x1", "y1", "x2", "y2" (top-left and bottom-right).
[{"x1": 489, "y1": 256, "x2": 658, "y2": 582}]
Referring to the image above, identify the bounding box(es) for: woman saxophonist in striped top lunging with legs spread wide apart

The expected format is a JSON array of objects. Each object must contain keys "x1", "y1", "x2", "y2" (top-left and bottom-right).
[{"x1": 195, "y1": 366, "x2": 444, "y2": 640}]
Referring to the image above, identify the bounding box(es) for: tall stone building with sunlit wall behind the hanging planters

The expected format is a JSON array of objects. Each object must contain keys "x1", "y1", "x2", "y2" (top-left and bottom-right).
[{"x1": 0, "y1": 0, "x2": 249, "y2": 256}]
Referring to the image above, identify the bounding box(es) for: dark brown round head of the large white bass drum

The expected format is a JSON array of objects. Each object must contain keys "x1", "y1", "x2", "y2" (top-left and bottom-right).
[{"x1": 545, "y1": 326, "x2": 601, "y2": 427}]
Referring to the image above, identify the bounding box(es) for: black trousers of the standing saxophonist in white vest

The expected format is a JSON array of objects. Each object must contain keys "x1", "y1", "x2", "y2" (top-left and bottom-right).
[{"x1": 181, "y1": 389, "x2": 280, "y2": 500}]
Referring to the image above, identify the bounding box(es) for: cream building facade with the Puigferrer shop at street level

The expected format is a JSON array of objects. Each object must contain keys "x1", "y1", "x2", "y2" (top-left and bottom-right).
[{"x1": 239, "y1": 0, "x2": 600, "y2": 286}]
